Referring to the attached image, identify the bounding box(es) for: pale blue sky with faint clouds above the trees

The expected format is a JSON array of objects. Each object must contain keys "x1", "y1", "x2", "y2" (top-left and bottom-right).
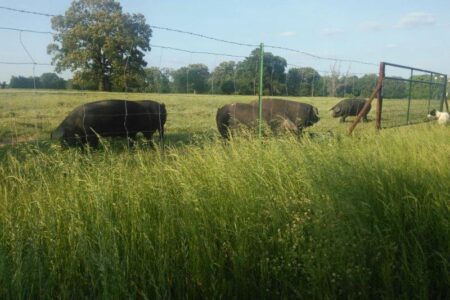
[{"x1": 0, "y1": 0, "x2": 450, "y2": 81}]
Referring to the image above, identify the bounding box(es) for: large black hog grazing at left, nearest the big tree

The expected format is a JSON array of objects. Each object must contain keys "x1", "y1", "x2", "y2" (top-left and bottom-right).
[{"x1": 51, "y1": 100, "x2": 167, "y2": 147}]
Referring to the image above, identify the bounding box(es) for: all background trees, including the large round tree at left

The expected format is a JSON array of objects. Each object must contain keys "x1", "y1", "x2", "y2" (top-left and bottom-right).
[{"x1": 0, "y1": 0, "x2": 438, "y2": 98}]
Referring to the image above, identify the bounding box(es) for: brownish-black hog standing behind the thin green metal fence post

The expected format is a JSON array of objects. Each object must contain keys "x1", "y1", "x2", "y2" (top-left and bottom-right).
[{"x1": 216, "y1": 99, "x2": 319, "y2": 138}]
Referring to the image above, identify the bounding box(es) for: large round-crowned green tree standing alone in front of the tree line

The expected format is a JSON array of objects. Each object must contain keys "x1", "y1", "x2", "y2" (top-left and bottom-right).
[{"x1": 47, "y1": 0, "x2": 152, "y2": 91}]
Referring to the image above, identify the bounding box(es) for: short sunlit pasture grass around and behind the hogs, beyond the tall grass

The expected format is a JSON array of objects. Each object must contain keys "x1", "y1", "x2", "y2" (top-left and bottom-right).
[{"x1": 0, "y1": 90, "x2": 375, "y2": 145}]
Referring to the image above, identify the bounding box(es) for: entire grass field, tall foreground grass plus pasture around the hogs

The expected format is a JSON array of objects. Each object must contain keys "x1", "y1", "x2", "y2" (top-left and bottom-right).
[{"x1": 0, "y1": 91, "x2": 450, "y2": 299}]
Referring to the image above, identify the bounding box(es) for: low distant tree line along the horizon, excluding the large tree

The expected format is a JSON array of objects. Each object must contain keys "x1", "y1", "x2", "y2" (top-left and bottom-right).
[{"x1": 0, "y1": 54, "x2": 441, "y2": 99}]
